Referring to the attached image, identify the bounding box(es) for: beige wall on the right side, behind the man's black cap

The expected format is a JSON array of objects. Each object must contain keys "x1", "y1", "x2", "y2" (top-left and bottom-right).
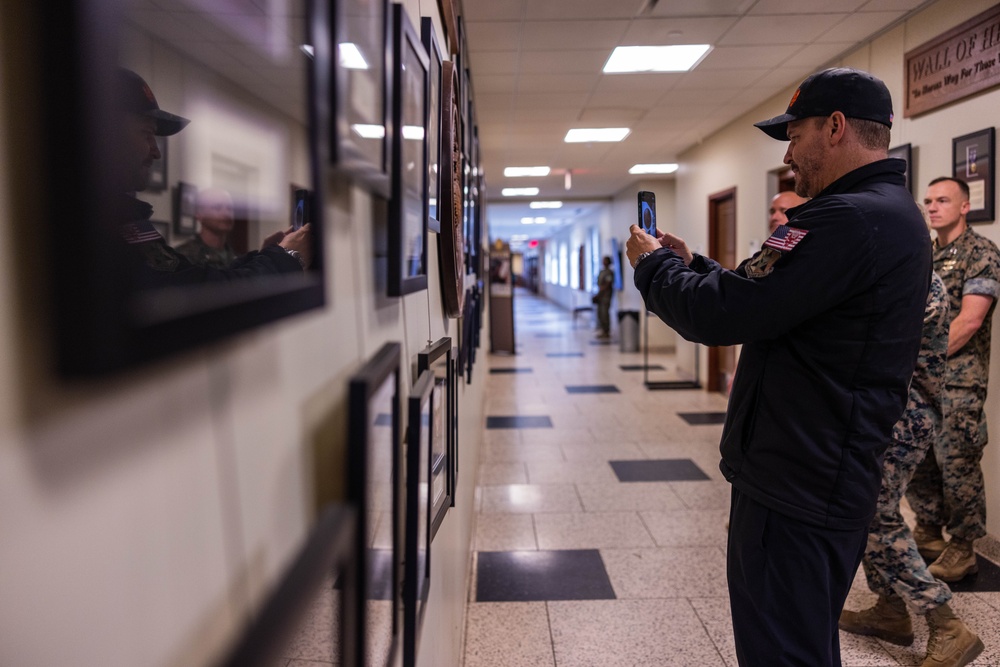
[{"x1": 677, "y1": 0, "x2": 1000, "y2": 535}]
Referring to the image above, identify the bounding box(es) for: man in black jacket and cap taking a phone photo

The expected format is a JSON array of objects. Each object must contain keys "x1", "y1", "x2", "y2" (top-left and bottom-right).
[{"x1": 627, "y1": 68, "x2": 931, "y2": 667}]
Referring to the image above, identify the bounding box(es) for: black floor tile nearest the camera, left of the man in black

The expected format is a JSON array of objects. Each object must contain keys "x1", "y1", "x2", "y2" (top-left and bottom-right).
[{"x1": 476, "y1": 549, "x2": 615, "y2": 602}]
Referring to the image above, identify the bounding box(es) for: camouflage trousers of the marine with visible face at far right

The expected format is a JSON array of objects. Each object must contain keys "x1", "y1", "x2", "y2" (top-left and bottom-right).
[{"x1": 906, "y1": 386, "x2": 987, "y2": 542}]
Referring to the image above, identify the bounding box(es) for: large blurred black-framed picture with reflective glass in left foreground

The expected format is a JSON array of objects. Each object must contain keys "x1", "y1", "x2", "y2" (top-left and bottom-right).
[{"x1": 43, "y1": 0, "x2": 325, "y2": 377}]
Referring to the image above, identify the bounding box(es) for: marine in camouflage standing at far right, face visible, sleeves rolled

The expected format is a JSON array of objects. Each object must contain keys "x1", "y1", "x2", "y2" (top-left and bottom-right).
[{"x1": 906, "y1": 177, "x2": 1000, "y2": 582}]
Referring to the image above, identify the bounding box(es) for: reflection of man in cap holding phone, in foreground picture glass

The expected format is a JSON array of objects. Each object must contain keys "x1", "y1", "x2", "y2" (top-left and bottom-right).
[{"x1": 116, "y1": 68, "x2": 312, "y2": 288}]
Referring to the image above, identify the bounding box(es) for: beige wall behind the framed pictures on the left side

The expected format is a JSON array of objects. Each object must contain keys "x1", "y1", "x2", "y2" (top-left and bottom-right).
[{"x1": 0, "y1": 0, "x2": 488, "y2": 667}]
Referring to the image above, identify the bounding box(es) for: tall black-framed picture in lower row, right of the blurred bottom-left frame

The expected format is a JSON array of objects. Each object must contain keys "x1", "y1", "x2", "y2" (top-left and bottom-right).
[{"x1": 347, "y1": 342, "x2": 406, "y2": 667}]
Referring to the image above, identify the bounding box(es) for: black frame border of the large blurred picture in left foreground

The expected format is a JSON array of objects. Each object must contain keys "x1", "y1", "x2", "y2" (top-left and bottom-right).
[{"x1": 42, "y1": 0, "x2": 325, "y2": 377}]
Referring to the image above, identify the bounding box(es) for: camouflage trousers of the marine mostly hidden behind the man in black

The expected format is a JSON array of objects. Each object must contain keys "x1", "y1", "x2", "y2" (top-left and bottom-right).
[{"x1": 861, "y1": 428, "x2": 951, "y2": 614}]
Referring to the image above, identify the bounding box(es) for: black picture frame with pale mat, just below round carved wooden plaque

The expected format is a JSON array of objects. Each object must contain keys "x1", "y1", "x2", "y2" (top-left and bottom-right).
[{"x1": 417, "y1": 336, "x2": 456, "y2": 541}]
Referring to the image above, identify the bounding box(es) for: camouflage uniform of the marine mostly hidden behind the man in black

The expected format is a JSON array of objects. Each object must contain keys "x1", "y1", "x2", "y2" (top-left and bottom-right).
[{"x1": 862, "y1": 274, "x2": 951, "y2": 614}]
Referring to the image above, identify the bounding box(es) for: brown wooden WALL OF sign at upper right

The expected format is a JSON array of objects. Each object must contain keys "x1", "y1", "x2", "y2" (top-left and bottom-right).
[{"x1": 903, "y1": 5, "x2": 1000, "y2": 118}]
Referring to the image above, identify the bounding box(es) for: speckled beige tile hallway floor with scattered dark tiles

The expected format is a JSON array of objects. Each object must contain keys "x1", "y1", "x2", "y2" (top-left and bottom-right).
[{"x1": 465, "y1": 291, "x2": 1000, "y2": 667}]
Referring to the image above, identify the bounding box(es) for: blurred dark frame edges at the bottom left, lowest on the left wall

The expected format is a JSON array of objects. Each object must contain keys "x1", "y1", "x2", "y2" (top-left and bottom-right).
[{"x1": 221, "y1": 505, "x2": 364, "y2": 667}]
